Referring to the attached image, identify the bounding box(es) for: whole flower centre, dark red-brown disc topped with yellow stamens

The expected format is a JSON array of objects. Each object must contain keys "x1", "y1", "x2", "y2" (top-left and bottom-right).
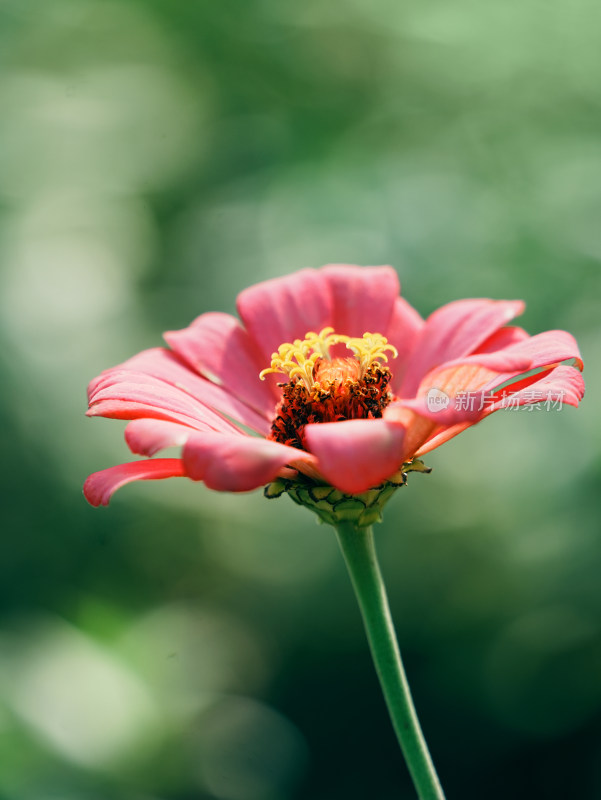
[{"x1": 260, "y1": 328, "x2": 397, "y2": 449}]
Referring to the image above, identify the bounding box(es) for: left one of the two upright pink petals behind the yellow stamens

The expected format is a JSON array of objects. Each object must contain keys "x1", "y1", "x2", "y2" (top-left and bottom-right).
[{"x1": 237, "y1": 269, "x2": 332, "y2": 368}]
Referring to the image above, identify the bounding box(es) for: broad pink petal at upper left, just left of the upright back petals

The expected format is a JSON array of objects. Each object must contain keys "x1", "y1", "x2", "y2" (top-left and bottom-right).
[{"x1": 164, "y1": 313, "x2": 280, "y2": 412}]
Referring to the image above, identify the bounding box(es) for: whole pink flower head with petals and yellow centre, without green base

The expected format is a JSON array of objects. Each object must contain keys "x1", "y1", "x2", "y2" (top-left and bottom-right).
[{"x1": 84, "y1": 265, "x2": 584, "y2": 506}]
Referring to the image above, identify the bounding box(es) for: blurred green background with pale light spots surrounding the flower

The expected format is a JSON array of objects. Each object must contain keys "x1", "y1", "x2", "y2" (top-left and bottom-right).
[{"x1": 0, "y1": 0, "x2": 601, "y2": 800}]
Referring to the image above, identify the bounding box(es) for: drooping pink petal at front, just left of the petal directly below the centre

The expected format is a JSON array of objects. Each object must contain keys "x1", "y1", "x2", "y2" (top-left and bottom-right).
[{"x1": 183, "y1": 431, "x2": 315, "y2": 492}]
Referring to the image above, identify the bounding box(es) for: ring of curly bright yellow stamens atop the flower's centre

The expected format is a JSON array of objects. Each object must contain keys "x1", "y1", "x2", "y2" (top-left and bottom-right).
[{"x1": 259, "y1": 328, "x2": 398, "y2": 391}]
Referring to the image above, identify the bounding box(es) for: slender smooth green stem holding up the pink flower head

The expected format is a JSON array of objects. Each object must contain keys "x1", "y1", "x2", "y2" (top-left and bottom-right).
[{"x1": 336, "y1": 523, "x2": 444, "y2": 800}]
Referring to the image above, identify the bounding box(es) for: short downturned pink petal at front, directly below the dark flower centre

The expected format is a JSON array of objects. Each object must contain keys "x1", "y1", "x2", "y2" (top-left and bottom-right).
[{"x1": 305, "y1": 419, "x2": 405, "y2": 494}]
